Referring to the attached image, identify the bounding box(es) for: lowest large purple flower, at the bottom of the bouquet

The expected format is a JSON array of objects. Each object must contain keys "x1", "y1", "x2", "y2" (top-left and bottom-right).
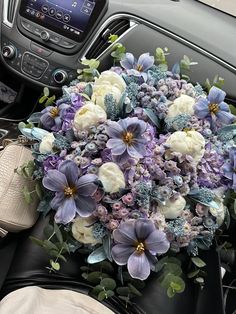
[{"x1": 112, "y1": 218, "x2": 170, "y2": 280}]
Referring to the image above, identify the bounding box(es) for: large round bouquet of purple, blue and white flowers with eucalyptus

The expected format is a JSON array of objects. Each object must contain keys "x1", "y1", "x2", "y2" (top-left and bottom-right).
[{"x1": 19, "y1": 47, "x2": 236, "y2": 300}]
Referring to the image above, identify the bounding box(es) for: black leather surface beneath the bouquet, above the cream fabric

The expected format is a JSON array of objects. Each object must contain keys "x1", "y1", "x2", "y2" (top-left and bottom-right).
[{"x1": 0, "y1": 219, "x2": 223, "y2": 314}]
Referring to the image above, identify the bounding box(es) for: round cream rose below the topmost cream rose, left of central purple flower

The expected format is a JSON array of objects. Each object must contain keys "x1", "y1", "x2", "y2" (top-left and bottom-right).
[{"x1": 74, "y1": 101, "x2": 107, "y2": 131}]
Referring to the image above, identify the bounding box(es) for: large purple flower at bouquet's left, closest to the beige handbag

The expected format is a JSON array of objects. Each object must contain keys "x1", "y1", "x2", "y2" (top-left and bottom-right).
[{"x1": 43, "y1": 160, "x2": 97, "y2": 224}]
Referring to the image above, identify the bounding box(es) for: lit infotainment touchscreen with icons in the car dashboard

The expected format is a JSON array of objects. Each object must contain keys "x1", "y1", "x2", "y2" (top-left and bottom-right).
[{"x1": 20, "y1": 0, "x2": 107, "y2": 41}]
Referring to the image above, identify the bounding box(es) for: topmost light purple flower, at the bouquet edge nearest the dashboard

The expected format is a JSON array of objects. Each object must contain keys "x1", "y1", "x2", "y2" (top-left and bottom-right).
[{"x1": 120, "y1": 53, "x2": 154, "y2": 81}]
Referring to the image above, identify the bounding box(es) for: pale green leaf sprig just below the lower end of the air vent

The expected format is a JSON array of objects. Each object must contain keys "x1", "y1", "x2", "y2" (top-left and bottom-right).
[{"x1": 77, "y1": 59, "x2": 100, "y2": 81}]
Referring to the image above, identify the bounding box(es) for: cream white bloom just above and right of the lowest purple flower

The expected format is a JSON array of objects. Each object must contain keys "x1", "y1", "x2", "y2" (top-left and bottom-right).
[{"x1": 157, "y1": 196, "x2": 186, "y2": 219}]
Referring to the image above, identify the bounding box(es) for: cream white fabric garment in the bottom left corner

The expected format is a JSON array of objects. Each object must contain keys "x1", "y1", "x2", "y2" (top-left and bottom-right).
[{"x1": 0, "y1": 287, "x2": 114, "y2": 314}]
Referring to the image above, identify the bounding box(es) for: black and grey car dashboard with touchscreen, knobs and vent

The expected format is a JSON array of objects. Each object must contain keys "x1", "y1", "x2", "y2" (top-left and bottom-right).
[{"x1": 1, "y1": 0, "x2": 236, "y2": 99}]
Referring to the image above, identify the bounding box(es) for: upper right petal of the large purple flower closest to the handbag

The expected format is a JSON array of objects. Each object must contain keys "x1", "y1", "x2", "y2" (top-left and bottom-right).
[{"x1": 76, "y1": 174, "x2": 98, "y2": 196}]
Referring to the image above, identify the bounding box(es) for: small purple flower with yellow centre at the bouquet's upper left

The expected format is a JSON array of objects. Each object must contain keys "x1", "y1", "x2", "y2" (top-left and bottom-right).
[{"x1": 40, "y1": 104, "x2": 70, "y2": 132}]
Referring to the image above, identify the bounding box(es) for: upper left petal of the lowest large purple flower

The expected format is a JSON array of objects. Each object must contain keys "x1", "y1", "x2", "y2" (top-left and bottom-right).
[{"x1": 113, "y1": 220, "x2": 138, "y2": 245}]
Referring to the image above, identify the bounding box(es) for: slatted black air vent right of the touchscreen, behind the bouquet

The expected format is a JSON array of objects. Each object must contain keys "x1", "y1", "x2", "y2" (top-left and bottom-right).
[{"x1": 85, "y1": 19, "x2": 131, "y2": 59}]
